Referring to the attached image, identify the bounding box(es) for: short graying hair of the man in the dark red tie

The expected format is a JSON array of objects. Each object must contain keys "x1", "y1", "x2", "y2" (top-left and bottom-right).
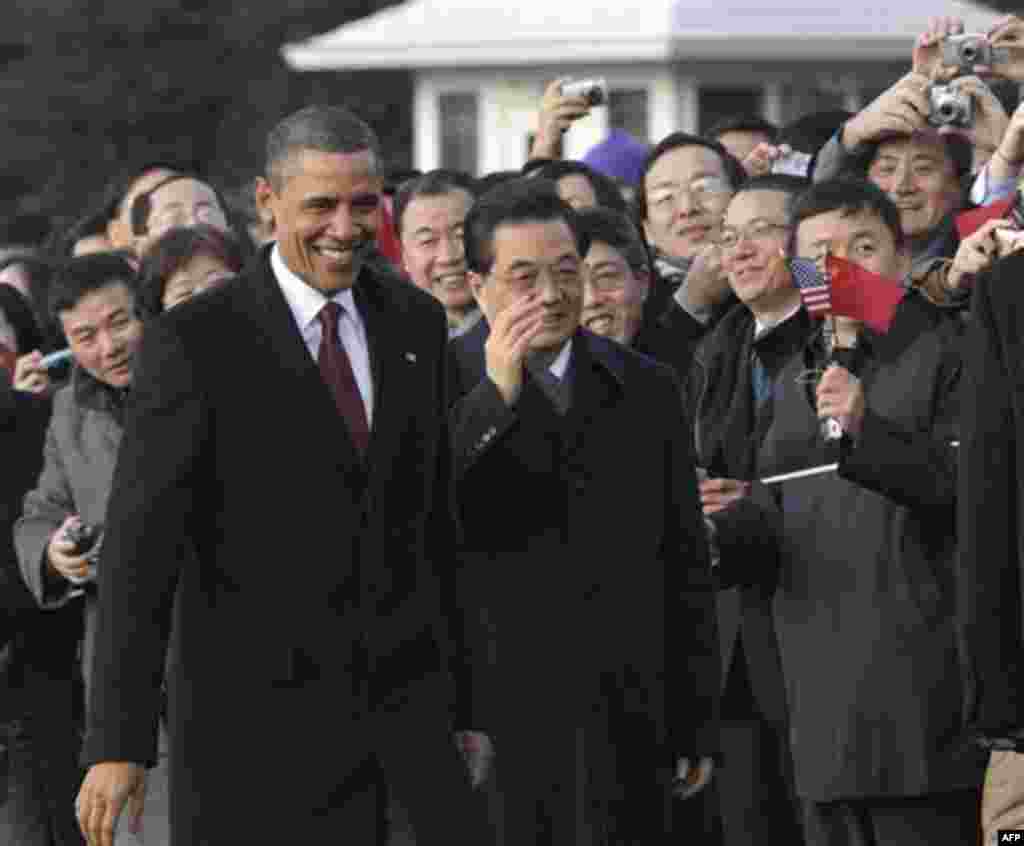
[{"x1": 265, "y1": 105, "x2": 383, "y2": 193}]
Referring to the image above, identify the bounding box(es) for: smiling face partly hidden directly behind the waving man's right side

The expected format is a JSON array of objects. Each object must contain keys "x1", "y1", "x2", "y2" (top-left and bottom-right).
[{"x1": 582, "y1": 241, "x2": 650, "y2": 346}]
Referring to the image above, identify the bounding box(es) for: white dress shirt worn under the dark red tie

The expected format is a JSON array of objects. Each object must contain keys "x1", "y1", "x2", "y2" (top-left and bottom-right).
[{"x1": 270, "y1": 244, "x2": 374, "y2": 426}]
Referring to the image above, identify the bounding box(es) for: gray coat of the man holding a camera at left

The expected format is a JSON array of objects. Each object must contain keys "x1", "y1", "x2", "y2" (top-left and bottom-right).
[{"x1": 14, "y1": 370, "x2": 122, "y2": 689}]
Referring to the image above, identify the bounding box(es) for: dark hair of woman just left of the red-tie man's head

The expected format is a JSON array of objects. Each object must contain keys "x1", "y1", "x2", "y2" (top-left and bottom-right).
[{"x1": 138, "y1": 223, "x2": 246, "y2": 318}]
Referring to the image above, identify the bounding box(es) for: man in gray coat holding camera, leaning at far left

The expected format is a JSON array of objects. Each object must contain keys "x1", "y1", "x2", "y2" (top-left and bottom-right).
[{"x1": 13, "y1": 253, "x2": 167, "y2": 834}]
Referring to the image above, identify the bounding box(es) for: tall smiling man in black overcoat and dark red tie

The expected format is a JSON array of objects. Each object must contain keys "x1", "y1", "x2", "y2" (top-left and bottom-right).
[{"x1": 78, "y1": 107, "x2": 485, "y2": 846}]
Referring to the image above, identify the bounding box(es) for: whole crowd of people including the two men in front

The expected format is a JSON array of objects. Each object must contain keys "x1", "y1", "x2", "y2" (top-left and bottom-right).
[{"x1": 0, "y1": 11, "x2": 1024, "y2": 846}]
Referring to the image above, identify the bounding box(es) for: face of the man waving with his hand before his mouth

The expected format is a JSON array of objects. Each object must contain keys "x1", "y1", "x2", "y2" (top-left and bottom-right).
[{"x1": 470, "y1": 218, "x2": 583, "y2": 351}]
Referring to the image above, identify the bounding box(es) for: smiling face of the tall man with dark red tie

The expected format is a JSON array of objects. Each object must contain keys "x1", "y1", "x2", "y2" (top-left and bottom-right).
[{"x1": 257, "y1": 150, "x2": 382, "y2": 294}]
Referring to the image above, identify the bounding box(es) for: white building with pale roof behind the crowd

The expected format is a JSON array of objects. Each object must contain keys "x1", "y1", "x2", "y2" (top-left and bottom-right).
[{"x1": 283, "y1": 0, "x2": 997, "y2": 174}]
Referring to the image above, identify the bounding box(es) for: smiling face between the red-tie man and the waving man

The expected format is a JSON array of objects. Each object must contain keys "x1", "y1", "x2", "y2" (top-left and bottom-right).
[{"x1": 399, "y1": 188, "x2": 474, "y2": 316}]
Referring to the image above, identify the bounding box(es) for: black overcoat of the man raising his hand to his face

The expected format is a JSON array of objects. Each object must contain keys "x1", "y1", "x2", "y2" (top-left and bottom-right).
[{"x1": 453, "y1": 327, "x2": 718, "y2": 843}]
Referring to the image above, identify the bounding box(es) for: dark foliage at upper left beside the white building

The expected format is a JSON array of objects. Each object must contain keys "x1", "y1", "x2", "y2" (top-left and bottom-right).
[{"x1": 0, "y1": 0, "x2": 412, "y2": 238}]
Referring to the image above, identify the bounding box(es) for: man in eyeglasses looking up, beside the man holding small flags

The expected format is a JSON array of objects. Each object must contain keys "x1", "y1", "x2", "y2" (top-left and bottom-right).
[{"x1": 687, "y1": 175, "x2": 812, "y2": 846}]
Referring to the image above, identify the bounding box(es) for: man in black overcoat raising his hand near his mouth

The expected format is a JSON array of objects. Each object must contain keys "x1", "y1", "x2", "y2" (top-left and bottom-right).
[{"x1": 453, "y1": 180, "x2": 718, "y2": 844}]
